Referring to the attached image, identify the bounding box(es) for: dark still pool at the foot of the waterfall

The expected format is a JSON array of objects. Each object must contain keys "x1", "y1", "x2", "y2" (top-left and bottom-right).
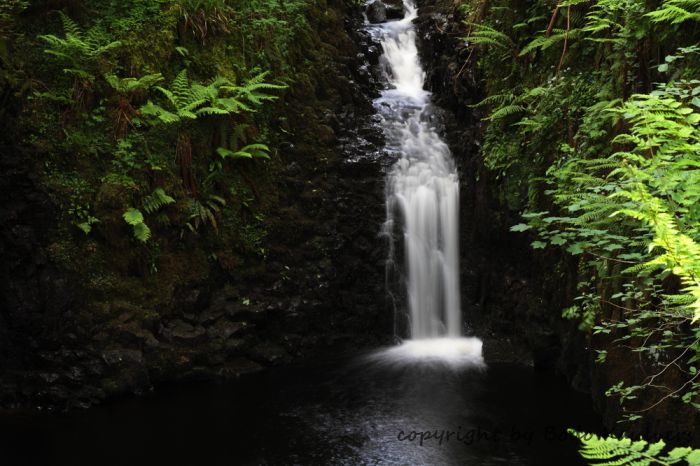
[{"x1": 0, "y1": 359, "x2": 599, "y2": 466}]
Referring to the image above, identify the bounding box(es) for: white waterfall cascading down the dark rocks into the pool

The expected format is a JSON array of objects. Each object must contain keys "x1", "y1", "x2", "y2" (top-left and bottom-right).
[{"x1": 371, "y1": 0, "x2": 483, "y2": 366}]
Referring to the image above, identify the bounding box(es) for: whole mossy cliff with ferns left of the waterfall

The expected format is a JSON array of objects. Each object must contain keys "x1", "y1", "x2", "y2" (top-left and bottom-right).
[{"x1": 0, "y1": 0, "x2": 390, "y2": 407}]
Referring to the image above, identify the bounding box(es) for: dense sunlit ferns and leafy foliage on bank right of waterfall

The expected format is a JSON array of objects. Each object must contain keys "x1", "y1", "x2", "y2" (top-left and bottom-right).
[{"x1": 464, "y1": 0, "x2": 700, "y2": 420}]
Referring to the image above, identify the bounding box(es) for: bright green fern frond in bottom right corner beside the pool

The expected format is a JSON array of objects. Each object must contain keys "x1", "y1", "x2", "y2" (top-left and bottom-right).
[{"x1": 569, "y1": 429, "x2": 700, "y2": 466}]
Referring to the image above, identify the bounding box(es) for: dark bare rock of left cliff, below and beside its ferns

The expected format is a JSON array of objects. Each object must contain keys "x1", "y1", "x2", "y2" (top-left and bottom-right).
[{"x1": 0, "y1": 0, "x2": 391, "y2": 409}]
